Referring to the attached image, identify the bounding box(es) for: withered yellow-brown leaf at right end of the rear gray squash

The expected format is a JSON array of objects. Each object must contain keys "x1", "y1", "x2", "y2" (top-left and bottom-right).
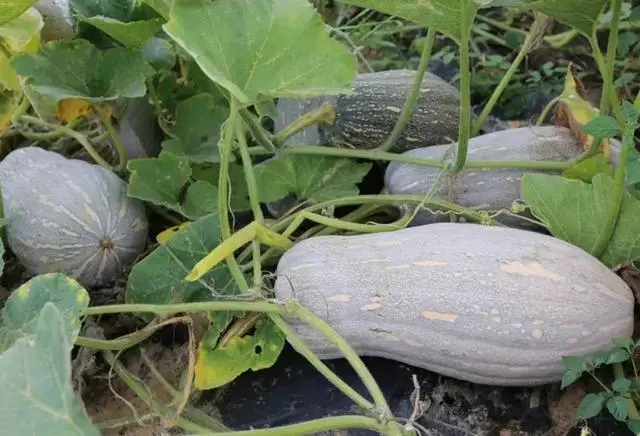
[{"x1": 555, "y1": 65, "x2": 611, "y2": 158}]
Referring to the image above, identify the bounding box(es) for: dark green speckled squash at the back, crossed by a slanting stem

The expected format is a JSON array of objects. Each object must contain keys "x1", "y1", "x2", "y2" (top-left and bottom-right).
[{"x1": 329, "y1": 70, "x2": 460, "y2": 152}]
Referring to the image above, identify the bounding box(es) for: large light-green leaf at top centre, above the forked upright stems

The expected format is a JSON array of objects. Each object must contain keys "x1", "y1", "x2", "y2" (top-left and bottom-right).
[{"x1": 163, "y1": 0, "x2": 356, "y2": 104}]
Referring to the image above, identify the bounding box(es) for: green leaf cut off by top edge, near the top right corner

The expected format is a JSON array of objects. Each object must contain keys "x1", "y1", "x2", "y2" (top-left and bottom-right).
[{"x1": 522, "y1": 0, "x2": 607, "y2": 38}]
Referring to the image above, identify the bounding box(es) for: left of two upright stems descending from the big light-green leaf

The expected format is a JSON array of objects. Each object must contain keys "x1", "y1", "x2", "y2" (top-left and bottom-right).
[{"x1": 218, "y1": 103, "x2": 249, "y2": 293}]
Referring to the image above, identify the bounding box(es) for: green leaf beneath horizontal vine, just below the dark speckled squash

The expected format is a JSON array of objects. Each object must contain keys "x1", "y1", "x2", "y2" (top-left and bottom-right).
[{"x1": 255, "y1": 154, "x2": 372, "y2": 203}]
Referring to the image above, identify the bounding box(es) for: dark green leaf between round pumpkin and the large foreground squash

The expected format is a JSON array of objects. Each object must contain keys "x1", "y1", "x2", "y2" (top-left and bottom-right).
[{"x1": 126, "y1": 213, "x2": 238, "y2": 304}]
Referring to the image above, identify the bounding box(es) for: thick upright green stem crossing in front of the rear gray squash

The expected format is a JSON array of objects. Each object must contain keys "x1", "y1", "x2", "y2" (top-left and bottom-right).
[{"x1": 451, "y1": 0, "x2": 473, "y2": 173}]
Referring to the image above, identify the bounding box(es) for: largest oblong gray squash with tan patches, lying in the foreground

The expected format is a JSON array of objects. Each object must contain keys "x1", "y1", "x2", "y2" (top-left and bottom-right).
[{"x1": 274, "y1": 223, "x2": 634, "y2": 386}]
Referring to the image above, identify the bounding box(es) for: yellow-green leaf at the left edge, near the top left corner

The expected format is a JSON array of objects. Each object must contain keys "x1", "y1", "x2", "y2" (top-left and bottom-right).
[{"x1": 0, "y1": 8, "x2": 44, "y2": 91}]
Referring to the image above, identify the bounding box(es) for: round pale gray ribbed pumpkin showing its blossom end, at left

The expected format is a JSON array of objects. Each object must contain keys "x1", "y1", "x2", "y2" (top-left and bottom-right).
[{"x1": 0, "y1": 147, "x2": 148, "y2": 287}]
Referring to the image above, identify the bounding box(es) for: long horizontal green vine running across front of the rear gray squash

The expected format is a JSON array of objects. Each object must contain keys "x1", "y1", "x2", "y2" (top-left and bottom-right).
[{"x1": 272, "y1": 145, "x2": 572, "y2": 171}]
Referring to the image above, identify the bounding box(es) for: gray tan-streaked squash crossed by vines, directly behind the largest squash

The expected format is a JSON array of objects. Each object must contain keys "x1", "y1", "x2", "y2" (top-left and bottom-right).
[{"x1": 384, "y1": 126, "x2": 582, "y2": 228}]
